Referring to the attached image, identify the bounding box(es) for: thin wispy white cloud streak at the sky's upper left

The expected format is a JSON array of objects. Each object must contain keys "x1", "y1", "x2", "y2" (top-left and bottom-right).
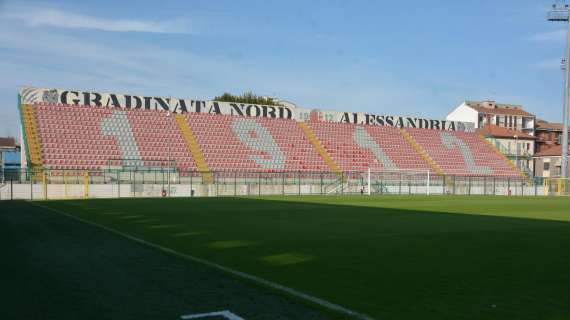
[{"x1": 0, "y1": 7, "x2": 190, "y2": 33}]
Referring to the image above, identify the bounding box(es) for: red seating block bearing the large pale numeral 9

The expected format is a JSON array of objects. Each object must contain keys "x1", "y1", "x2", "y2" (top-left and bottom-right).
[{"x1": 180, "y1": 113, "x2": 328, "y2": 172}]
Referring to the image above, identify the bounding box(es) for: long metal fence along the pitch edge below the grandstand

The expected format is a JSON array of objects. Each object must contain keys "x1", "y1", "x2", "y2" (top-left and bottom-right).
[{"x1": 0, "y1": 168, "x2": 549, "y2": 200}]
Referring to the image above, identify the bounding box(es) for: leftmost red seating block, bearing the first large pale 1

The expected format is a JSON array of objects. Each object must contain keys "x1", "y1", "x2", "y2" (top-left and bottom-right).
[{"x1": 35, "y1": 104, "x2": 196, "y2": 170}]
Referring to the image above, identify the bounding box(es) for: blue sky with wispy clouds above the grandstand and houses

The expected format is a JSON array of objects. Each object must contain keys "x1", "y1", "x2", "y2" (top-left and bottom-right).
[{"x1": 0, "y1": 0, "x2": 565, "y2": 136}]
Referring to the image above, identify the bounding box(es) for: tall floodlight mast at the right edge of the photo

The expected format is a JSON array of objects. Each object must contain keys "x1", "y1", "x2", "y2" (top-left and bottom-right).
[{"x1": 547, "y1": 4, "x2": 570, "y2": 178}]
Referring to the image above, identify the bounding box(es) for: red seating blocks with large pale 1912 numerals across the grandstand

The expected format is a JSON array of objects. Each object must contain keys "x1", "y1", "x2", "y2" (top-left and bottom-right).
[{"x1": 28, "y1": 103, "x2": 519, "y2": 177}]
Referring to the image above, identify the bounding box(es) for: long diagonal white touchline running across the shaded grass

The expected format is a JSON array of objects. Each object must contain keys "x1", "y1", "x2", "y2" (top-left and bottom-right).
[{"x1": 32, "y1": 200, "x2": 374, "y2": 320}]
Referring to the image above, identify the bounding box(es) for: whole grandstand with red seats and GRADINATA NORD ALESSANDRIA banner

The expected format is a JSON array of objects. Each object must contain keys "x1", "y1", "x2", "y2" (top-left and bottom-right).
[{"x1": 1, "y1": 87, "x2": 537, "y2": 198}]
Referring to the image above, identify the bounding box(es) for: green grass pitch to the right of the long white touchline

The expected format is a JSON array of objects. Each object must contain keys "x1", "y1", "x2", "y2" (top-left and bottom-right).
[{"x1": 4, "y1": 196, "x2": 570, "y2": 320}]
